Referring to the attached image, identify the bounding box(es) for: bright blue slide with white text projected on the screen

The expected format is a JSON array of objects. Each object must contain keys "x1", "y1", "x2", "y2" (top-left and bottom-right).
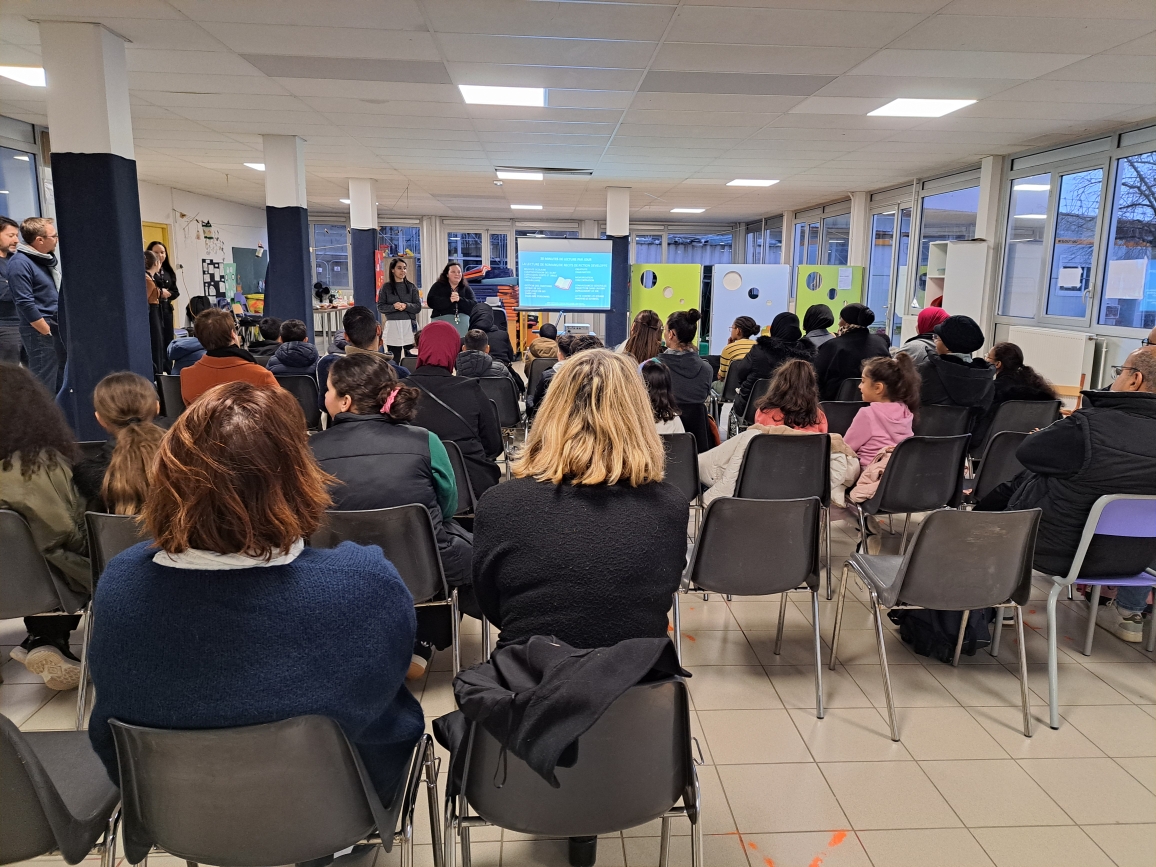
[{"x1": 518, "y1": 238, "x2": 612, "y2": 311}]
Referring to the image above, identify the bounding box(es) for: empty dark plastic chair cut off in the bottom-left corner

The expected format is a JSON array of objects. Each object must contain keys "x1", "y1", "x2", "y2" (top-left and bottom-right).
[{"x1": 0, "y1": 717, "x2": 120, "y2": 867}]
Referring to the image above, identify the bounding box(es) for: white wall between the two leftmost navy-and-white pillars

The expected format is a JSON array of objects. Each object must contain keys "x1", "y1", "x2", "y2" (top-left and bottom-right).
[{"x1": 138, "y1": 181, "x2": 269, "y2": 324}]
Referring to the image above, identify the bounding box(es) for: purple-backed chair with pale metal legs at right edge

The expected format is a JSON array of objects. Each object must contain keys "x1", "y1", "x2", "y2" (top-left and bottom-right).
[{"x1": 1047, "y1": 494, "x2": 1156, "y2": 728}]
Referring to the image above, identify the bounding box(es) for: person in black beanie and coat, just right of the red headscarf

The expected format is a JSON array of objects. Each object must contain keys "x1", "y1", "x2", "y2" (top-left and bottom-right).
[{"x1": 917, "y1": 316, "x2": 995, "y2": 417}]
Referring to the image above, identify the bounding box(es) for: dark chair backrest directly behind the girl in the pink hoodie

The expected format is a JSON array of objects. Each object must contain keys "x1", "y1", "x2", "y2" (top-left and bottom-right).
[{"x1": 864, "y1": 434, "x2": 968, "y2": 513}]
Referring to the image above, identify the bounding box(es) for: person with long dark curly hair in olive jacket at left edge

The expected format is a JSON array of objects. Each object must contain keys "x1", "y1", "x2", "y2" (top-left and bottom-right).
[{"x1": 0, "y1": 364, "x2": 91, "y2": 689}]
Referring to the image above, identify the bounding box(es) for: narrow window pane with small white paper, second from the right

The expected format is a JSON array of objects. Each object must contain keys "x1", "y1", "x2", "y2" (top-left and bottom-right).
[{"x1": 1047, "y1": 169, "x2": 1104, "y2": 319}]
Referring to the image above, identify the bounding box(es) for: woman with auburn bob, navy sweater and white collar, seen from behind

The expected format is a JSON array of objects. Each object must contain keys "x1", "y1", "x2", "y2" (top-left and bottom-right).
[{"x1": 89, "y1": 383, "x2": 423, "y2": 801}]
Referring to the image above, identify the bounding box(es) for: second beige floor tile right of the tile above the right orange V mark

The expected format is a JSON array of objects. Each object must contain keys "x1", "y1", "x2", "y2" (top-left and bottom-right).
[{"x1": 919, "y1": 758, "x2": 1072, "y2": 828}]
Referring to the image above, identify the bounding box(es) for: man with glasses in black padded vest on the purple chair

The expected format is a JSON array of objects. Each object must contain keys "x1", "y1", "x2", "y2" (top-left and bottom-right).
[{"x1": 980, "y1": 346, "x2": 1156, "y2": 642}]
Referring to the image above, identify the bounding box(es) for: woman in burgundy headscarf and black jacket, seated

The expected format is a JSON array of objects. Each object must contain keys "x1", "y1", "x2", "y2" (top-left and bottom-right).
[{"x1": 406, "y1": 321, "x2": 502, "y2": 496}]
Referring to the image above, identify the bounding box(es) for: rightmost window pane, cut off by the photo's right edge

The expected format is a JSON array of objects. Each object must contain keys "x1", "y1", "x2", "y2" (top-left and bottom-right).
[{"x1": 1099, "y1": 151, "x2": 1156, "y2": 328}]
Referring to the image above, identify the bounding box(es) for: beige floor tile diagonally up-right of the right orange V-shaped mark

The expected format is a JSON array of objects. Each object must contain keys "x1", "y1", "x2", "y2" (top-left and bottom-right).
[{"x1": 820, "y1": 762, "x2": 959, "y2": 831}]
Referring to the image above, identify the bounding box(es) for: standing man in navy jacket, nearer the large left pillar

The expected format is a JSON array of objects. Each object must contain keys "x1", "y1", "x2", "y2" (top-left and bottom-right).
[{"x1": 8, "y1": 217, "x2": 67, "y2": 395}]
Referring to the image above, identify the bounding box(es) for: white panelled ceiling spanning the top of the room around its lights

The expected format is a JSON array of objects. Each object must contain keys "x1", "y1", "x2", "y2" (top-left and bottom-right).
[{"x1": 0, "y1": 0, "x2": 1156, "y2": 223}]
